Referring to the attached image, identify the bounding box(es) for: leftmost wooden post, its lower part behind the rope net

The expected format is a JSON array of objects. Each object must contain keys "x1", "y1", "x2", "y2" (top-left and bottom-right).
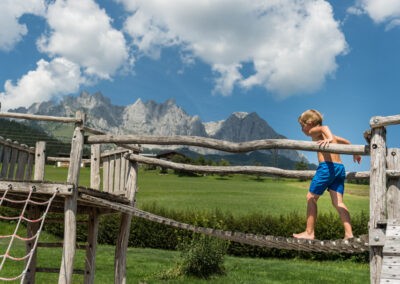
[{"x1": 24, "y1": 141, "x2": 46, "y2": 284}]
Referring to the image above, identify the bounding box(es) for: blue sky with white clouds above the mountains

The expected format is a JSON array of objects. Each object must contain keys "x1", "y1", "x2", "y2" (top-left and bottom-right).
[{"x1": 0, "y1": 0, "x2": 400, "y2": 170}]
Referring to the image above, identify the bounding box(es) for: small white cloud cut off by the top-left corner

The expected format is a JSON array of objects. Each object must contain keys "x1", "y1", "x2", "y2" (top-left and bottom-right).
[{"x1": 0, "y1": 0, "x2": 45, "y2": 51}]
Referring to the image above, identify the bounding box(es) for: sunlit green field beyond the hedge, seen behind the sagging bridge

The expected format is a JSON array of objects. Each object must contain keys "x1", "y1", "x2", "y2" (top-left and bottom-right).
[{"x1": 136, "y1": 171, "x2": 369, "y2": 215}]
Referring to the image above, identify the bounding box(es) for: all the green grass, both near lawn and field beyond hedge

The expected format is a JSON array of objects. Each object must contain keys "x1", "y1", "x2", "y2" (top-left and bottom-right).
[{"x1": 0, "y1": 166, "x2": 369, "y2": 283}]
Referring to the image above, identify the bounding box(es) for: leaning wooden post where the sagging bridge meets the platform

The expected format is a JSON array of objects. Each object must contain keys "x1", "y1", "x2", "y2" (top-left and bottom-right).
[{"x1": 114, "y1": 162, "x2": 138, "y2": 284}]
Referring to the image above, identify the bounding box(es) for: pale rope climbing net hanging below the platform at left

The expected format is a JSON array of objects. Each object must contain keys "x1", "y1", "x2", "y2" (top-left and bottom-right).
[{"x1": 0, "y1": 186, "x2": 58, "y2": 283}]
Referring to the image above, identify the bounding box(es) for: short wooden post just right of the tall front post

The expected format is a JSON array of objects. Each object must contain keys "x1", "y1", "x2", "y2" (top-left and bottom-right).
[{"x1": 84, "y1": 144, "x2": 101, "y2": 284}]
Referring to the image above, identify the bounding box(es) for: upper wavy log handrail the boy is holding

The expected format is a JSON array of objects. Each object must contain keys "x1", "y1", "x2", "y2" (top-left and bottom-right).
[{"x1": 86, "y1": 135, "x2": 369, "y2": 155}]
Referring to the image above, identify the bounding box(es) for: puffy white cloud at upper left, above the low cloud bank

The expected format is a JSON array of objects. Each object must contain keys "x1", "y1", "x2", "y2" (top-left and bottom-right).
[{"x1": 38, "y1": 0, "x2": 128, "y2": 79}]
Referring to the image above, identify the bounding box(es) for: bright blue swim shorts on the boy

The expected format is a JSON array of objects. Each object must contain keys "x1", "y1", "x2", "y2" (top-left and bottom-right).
[{"x1": 310, "y1": 162, "x2": 346, "y2": 195}]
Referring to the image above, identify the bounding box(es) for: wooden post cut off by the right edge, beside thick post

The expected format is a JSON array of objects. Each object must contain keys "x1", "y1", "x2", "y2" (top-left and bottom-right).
[{"x1": 386, "y1": 148, "x2": 400, "y2": 219}]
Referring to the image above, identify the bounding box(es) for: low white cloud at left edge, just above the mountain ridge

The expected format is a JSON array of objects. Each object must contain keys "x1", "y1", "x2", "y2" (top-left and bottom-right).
[{"x1": 0, "y1": 58, "x2": 82, "y2": 110}]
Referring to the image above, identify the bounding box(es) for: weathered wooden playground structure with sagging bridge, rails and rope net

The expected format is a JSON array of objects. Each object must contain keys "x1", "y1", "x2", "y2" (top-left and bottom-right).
[{"x1": 0, "y1": 112, "x2": 400, "y2": 283}]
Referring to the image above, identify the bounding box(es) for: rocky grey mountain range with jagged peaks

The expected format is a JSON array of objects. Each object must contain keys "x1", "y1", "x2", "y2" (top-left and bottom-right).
[{"x1": 11, "y1": 92, "x2": 306, "y2": 161}]
